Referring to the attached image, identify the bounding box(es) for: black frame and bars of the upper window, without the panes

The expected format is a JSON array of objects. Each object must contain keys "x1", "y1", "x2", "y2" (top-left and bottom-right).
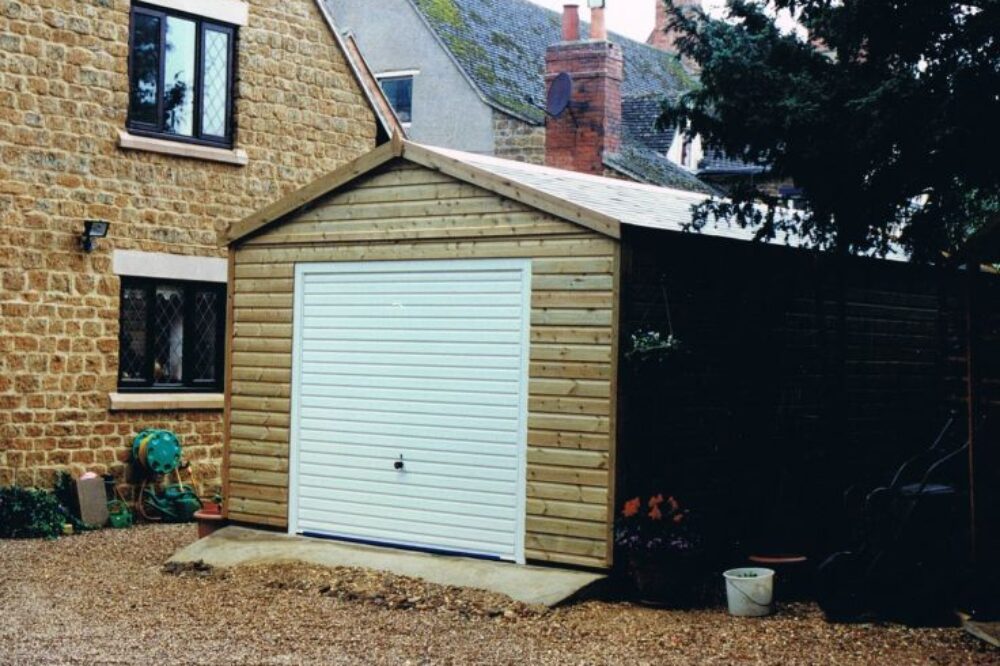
[{"x1": 125, "y1": 2, "x2": 239, "y2": 148}]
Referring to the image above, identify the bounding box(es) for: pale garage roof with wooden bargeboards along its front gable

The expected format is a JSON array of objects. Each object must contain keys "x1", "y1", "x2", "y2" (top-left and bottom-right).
[{"x1": 224, "y1": 135, "x2": 754, "y2": 244}]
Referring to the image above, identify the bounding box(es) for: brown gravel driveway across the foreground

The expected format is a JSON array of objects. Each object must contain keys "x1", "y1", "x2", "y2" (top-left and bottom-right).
[{"x1": 0, "y1": 526, "x2": 1000, "y2": 666}]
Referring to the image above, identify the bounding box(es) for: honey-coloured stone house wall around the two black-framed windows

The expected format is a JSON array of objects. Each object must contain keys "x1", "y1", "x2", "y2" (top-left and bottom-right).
[{"x1": 0, "y1": 0, "x2": 376, "y2": 492}]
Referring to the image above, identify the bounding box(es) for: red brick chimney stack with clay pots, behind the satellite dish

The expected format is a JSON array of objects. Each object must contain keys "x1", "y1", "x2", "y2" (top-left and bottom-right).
[{"x1": 545, "y1": 5, "x2": 624, "y2": 176}]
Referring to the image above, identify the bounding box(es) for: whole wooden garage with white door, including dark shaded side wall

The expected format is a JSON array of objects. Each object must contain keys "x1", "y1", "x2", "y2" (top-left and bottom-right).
[{"x1": 224, "y1": 140, "x2": 996, "y2": 568}]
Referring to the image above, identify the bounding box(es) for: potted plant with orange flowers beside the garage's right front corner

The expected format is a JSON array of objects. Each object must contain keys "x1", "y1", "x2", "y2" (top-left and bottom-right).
[{"x1": 615, "y1": 493, "x2": 704, "y2": 607}]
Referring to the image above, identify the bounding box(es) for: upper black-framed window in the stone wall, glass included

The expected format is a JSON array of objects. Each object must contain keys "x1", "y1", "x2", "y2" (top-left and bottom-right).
[{"x1": 128, "y1": 4, "x2": 236, "y2": 148}]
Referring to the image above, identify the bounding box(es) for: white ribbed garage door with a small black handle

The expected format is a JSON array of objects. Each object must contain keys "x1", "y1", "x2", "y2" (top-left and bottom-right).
[{"x1": 289, "y1": 259, "x2": 531, "y2": 562}]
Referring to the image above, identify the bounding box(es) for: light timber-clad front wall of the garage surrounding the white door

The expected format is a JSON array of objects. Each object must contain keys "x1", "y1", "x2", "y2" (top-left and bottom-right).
[{"x1": 226, "y1": 161, "x2": 618, "y2": 567}]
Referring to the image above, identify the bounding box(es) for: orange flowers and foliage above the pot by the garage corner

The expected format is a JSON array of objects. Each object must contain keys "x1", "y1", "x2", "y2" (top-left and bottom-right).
[{"x1": 615, "y1": 493, "x2": 701, "y2": 554}]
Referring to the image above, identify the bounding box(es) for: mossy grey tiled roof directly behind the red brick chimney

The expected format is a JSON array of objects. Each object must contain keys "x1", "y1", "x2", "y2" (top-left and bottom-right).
[{"x1": 402, "y1": 0, "x2": 692, "y2": 125}]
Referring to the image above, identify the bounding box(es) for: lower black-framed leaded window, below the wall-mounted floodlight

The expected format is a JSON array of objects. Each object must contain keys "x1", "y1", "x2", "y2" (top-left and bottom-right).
[{"x1": 118, "y1": 277, "x2": 226, "y2": 392}]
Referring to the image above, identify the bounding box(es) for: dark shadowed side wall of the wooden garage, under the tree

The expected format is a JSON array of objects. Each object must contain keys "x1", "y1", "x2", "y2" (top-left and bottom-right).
[{"x1": 618, "y1": 230, "x2": 964, "y2": 553}]
